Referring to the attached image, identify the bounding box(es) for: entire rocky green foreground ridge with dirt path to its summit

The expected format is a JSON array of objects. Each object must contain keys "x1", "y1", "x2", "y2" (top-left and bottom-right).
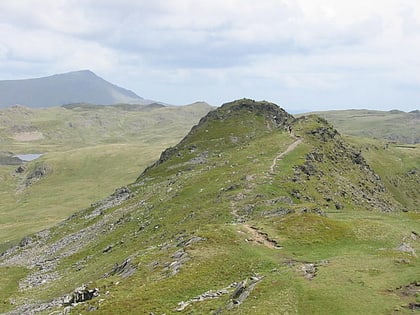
[{"x1": 0, "y1": 99, "x2": 420, "y2": 314}]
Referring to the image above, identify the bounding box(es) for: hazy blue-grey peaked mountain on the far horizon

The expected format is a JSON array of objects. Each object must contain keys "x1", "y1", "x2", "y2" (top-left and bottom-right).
[{"x1": 0, "y1": 70, "x2": 153, "y2": 108}]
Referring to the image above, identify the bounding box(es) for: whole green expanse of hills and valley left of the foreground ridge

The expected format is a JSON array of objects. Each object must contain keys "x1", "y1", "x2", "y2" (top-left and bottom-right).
[{"x1": 0, "y1": 103, "x2": 211, "y2": 248}]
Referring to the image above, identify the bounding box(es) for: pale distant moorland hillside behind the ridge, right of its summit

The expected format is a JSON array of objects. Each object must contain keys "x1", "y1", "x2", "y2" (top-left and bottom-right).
[{"x1": 302, "y1": 109, "x2": 420, "y2": 144}]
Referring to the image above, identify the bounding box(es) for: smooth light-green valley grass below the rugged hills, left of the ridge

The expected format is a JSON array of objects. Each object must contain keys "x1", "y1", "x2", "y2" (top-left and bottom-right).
[{"x1": 0, "y1": 144, "x2": 162, "y2": 242}]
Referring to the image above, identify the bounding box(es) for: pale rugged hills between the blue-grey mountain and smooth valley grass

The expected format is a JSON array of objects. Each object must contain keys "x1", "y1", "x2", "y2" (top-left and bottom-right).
[{"x1": 0, "y1": 103, "x2": 212, "y2": 154}]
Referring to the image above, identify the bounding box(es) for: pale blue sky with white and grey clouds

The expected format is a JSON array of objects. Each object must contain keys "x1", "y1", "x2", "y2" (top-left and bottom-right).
[{"x1": 0, "y1": 0, "x2": 420, "y2": 112}]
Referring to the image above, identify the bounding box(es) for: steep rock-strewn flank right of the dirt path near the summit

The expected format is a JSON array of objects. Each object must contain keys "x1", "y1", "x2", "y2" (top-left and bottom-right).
[{"x1": 289, "y1": 116, "x2": 403, "y2": 212}]
